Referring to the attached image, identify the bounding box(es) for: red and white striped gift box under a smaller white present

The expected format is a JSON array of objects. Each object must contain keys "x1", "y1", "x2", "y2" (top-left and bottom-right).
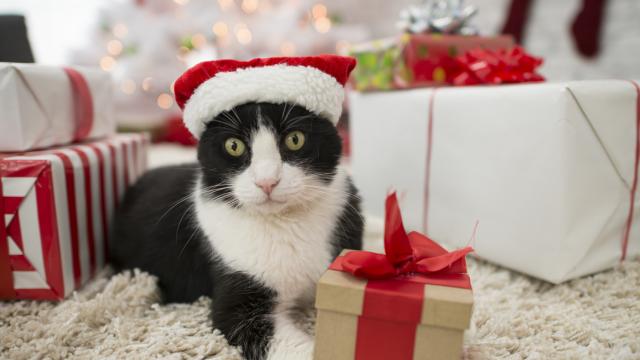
[{"x1": 0, "y1": 134, "x2": 149, "y2": 300}]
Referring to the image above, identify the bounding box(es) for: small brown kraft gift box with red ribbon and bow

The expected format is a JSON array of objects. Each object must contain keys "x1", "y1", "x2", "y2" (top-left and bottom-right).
[{"x1": 314, "y1": 195, "x2": 473, "y2": 360}]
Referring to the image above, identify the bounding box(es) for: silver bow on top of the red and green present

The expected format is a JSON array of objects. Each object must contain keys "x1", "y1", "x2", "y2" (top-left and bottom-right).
[{"x1": 398, "y1": 0, "x2": 478, "y2": 35}]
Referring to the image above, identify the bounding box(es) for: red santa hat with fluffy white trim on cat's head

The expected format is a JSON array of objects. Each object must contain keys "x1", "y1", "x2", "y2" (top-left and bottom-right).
[{"x1": 174, "y1": 55, "x2": 356, "y2": 138}]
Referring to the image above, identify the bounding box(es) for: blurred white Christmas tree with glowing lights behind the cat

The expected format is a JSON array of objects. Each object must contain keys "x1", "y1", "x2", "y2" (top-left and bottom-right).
[{"x1": 72, "y1": 0, "x2": 369, "y2": 138}]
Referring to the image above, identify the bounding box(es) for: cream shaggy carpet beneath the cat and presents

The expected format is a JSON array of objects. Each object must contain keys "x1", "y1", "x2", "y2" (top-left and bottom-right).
[{"x1": 0, "y1": 249, "x2": 640, "y2": 359}]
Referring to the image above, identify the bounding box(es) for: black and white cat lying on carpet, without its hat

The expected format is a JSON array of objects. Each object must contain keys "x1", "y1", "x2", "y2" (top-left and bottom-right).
[{"x1": 110, "y1": 102, "x2": 363, "y2": 360}]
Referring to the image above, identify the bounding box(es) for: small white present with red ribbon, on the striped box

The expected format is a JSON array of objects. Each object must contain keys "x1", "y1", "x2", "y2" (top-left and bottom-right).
[{"x1": 0, "y1": 63, "x2": 115, "y2": 151}]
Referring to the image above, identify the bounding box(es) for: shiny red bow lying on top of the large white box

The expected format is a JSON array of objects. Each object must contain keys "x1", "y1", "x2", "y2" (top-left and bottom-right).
[{"x1": 453, "y1": 46, "x2": 544, "y2": 86}]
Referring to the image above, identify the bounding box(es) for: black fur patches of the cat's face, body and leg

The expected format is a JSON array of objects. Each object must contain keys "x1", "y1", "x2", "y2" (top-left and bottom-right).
[{"x1": 110, "y1": 103, "x2": 363, "y2": 359}]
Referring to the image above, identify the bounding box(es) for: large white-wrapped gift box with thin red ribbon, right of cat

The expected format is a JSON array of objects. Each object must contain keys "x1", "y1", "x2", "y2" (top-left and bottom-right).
[{"x1": 350, "y1": 80, "x2": 640, "y2": 283}]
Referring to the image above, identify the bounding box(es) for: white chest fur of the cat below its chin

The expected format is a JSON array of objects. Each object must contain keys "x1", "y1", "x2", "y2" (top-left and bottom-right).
[{"x1": 195, "y1": 168, "x2": 348, "y2": 303}]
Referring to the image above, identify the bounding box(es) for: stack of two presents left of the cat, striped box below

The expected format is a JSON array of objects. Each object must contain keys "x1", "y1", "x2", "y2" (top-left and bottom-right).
[{"x1": 0, "y1": 63, "x2": 149, "y2": 300}]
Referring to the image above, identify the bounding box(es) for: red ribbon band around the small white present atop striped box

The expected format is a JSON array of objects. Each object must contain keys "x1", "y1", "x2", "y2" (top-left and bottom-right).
[{"x1": 64, "y1": 67, "x2": 93, "y2": 142}]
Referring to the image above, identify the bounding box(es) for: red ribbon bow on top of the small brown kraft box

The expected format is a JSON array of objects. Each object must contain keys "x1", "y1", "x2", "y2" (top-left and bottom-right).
[{"x1": 341, "y1": 192, "x2": 473, "y2": 279}]
